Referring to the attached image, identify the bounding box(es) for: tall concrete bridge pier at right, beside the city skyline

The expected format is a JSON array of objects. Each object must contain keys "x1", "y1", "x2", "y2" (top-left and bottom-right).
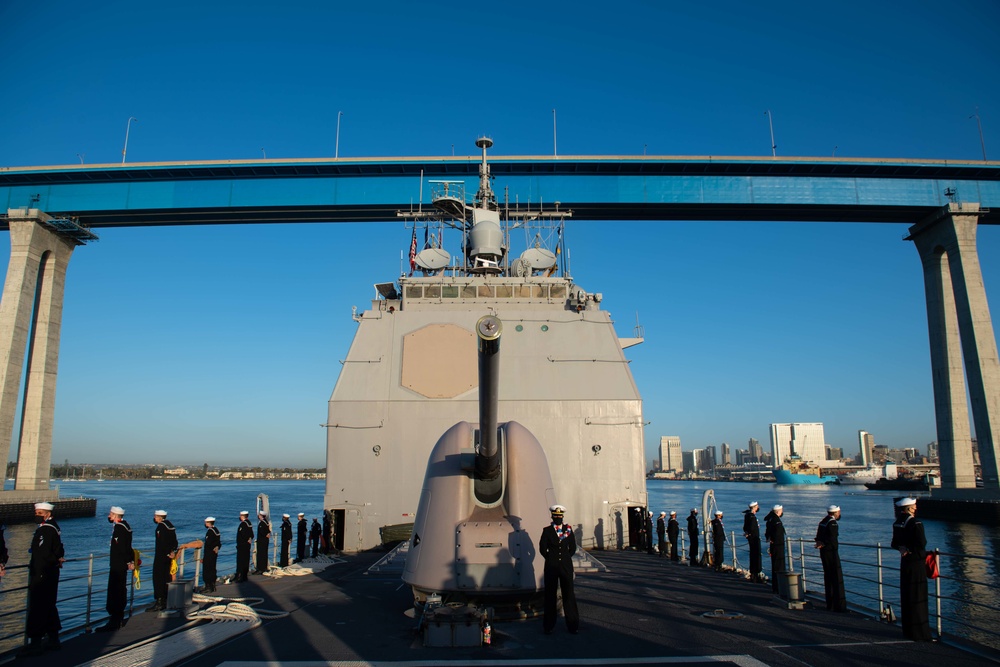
[{"x1": 908, "y1": 203, "x2": 1000, "y2": 489}]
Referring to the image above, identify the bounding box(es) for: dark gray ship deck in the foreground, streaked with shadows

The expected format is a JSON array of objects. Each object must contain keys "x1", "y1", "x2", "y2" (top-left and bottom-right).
[{"x1": 18, "y1": 552, "x2": 986, "y2": 667}]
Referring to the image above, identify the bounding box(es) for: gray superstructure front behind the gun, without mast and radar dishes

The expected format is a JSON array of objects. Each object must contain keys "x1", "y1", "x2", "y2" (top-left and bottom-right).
[{"x1": 324, "y1": 276, "x2": 646, "y2": 551}]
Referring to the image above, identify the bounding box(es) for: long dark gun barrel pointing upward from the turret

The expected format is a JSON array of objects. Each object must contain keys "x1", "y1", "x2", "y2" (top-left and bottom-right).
[{"x1": 476, "y1": 315, "x2": 503, "y2": 479}]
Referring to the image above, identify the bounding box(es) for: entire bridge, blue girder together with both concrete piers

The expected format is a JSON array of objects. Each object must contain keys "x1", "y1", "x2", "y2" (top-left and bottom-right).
[{"x1": 0, "y1": 156, "x2": 1000, "y2": 497}]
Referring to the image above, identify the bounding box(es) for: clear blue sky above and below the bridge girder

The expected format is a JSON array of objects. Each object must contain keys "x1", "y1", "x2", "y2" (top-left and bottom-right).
[{"x1": 0, "y1": 0, "x2": 1000, "y2": 466}]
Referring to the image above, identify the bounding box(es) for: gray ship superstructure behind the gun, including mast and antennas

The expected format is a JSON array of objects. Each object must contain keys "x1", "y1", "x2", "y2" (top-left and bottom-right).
[{"x1": 324, "y1": 137, "x2": 647, "y2": 552}]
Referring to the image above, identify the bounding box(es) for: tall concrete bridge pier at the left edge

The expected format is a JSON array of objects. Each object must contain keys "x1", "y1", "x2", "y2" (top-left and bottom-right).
[{"x1": 0, "y1": 209, "x2": 77, "y2": 491}]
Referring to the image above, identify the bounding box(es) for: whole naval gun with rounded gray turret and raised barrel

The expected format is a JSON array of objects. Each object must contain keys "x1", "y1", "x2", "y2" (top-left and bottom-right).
[{"x1": 403, "y1": 315, "x2": 556, "y2": 616}]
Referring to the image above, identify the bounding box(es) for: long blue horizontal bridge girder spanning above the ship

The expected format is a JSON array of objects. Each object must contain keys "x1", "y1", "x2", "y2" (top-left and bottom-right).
[{"x1": 0, "y1": 156, "x2": 1000, "y2": 228}]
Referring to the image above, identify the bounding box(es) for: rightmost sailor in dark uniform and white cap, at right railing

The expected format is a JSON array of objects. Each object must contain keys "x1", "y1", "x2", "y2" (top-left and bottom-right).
[{"x1": 892, "y1": 498, "x2": 934, "y2": 642}]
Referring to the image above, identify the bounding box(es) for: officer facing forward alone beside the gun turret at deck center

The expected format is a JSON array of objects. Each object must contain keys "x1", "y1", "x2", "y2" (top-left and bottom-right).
[{"x1": 538, "y1": 505, "x2": 580, "y2": 635}]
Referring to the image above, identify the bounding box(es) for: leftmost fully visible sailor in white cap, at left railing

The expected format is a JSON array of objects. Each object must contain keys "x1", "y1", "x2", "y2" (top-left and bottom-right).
[{"x1": 23, "y1": 503, "x2": 66, "y2": 655}]
